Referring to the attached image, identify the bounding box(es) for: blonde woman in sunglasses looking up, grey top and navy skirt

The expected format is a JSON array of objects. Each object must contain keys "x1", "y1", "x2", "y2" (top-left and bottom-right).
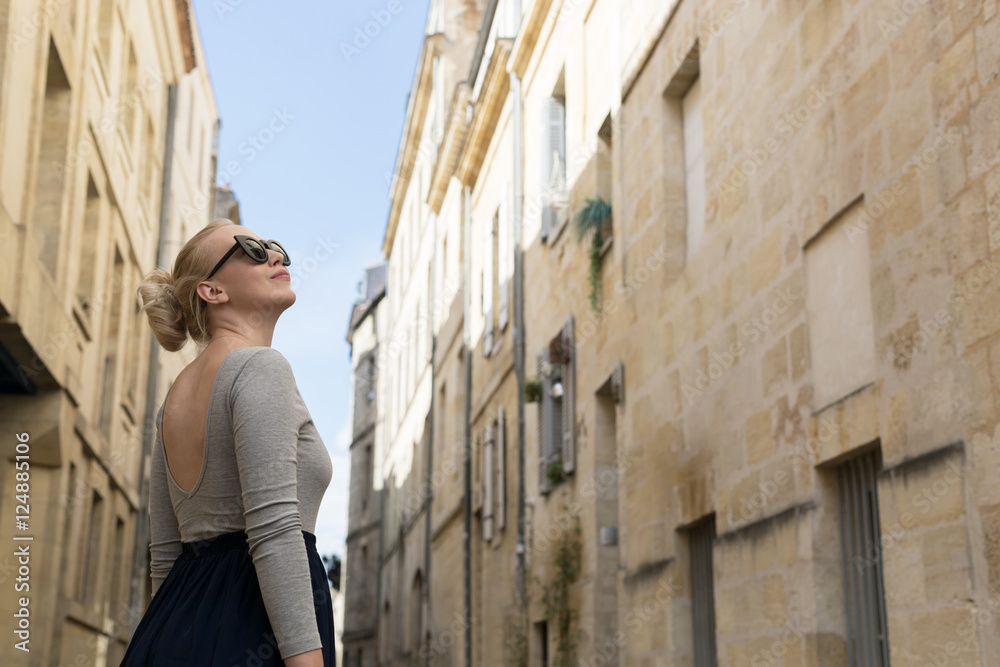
[{"x1": 121, "y1": 220, "x2": 336, "y2": 667}]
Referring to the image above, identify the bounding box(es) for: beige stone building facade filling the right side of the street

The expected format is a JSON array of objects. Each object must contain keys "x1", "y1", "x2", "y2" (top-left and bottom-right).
[{"x1": 349, "y1": 0, "x2": 1000, "y2": 667}]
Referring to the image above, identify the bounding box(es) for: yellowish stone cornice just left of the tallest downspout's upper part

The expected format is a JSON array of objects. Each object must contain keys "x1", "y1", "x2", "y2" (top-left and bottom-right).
[{"x1": 456, "y1": 37, "x2": 514, "y2": 187}]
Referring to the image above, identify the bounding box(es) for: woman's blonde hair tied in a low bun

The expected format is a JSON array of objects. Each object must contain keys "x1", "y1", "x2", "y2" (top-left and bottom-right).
[{"x1": 136, "y1": 218, "x2": 236, "y2": 352}]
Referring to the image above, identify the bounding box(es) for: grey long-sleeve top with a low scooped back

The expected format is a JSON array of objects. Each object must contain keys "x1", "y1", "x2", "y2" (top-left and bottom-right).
[{"x1": 149, "y1": 347, "x2": 333, "y2": 659}]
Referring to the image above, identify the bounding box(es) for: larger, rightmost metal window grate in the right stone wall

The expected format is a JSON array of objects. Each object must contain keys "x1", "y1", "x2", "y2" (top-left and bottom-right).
[{"x1": 837, "y1": 451, "x2": 889, "y2": 667}]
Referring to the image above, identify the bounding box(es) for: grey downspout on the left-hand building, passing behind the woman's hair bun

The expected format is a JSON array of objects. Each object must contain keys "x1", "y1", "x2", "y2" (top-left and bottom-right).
[{"x1": 129, "y1": 84, "x2": 177, "y2": 641}]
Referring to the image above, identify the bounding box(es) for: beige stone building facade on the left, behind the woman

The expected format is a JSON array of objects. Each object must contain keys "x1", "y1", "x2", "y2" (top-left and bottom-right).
[{"x1": 0, "y1": 0, "x2": 219, "y2": 666}]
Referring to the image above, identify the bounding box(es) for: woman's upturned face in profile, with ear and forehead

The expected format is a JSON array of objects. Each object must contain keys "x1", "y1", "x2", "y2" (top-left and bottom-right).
[{"x1": 198, "y1": 225, "x2": 295, "y2": 319}]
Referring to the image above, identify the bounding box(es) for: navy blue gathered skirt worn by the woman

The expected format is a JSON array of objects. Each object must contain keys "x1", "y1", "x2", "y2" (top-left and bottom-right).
[{"x1": 121, "y1": 530, "x2": 337, "y2": 667}]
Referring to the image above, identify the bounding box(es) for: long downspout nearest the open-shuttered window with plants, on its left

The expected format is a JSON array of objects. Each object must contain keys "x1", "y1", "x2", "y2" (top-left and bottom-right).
[{"x1": 510, "y1": 0, "x2": 526, "y2": 607}]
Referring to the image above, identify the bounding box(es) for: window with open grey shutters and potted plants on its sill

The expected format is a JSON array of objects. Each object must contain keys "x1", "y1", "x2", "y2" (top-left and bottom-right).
[{"x1": 537, "y1": 313, "x2": 576, "y2": 493}]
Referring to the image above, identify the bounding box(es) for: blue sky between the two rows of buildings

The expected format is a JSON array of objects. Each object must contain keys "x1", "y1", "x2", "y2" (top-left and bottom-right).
[{"x1": 193, "y1": 0, "x2": 429, "y2": 557}]
